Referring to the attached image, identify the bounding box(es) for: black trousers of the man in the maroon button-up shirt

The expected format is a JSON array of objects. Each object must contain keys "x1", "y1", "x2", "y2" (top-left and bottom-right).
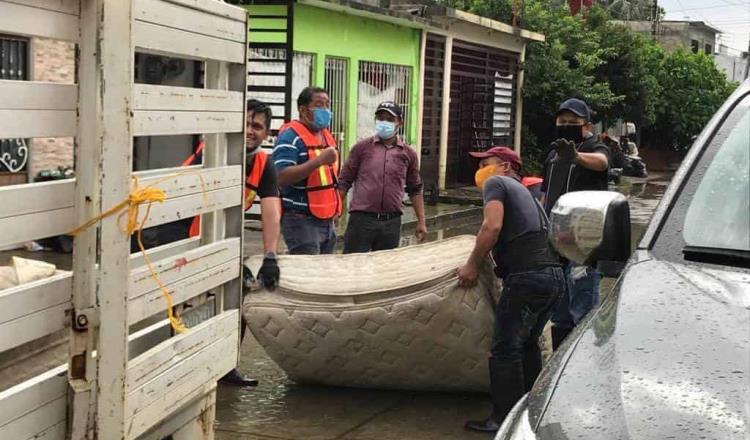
[{"x1": 344, "y1": 212, "x2": 401, "y2": 254}]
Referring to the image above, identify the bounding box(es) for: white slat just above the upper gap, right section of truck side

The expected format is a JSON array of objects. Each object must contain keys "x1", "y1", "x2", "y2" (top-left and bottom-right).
[{"x1": 133, "y1": 21, "x2": 245, "y2": 64}]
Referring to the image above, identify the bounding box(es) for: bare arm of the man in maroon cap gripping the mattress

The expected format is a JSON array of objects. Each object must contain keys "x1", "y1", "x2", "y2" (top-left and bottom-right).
[{"x1": 458, "y1": 200, "x2": 505, "y2": 287}]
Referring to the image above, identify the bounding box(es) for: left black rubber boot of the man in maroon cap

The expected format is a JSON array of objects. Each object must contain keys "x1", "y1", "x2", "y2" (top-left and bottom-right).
[{"x1": 465, "y1": 358, "x2": 526, "y2": 432}]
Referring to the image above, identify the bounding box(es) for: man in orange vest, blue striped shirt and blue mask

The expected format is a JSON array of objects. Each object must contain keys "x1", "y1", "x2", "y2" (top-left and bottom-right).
[{"x1": 272, "y1": 87, "x2": 341, "y2": 255}]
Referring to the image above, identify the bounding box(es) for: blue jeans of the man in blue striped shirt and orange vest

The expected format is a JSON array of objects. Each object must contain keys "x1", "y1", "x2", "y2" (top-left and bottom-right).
[{"x1": 281, "y1": 210, "x2": 336, "y2": 255}]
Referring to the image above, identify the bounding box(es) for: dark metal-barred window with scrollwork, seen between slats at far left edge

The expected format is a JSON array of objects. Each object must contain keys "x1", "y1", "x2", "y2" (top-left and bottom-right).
[{"x1": 0, "y1": 35, "x2": 29, "y2": 173}]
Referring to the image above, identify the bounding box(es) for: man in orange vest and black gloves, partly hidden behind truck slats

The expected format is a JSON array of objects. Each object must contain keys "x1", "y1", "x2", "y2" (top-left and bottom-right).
[{"x1": 221, "y1": 99, "x2": 281, "y2": 386}]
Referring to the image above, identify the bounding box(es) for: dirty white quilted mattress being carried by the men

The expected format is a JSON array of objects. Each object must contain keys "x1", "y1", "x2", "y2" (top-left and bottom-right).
[{"x1": 244, "y1": 236, "x2": 499, "y2": 391}]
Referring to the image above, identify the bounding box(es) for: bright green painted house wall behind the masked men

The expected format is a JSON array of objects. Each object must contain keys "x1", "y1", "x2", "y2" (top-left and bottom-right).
[{"x1": 248, "y1": 4, "x2": 420, "y2": 148}]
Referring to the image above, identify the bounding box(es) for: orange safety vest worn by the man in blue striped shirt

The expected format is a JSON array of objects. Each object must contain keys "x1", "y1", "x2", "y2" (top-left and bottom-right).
[{"x1": 279, "y1": 121, "x2": 342, "y2": 220}]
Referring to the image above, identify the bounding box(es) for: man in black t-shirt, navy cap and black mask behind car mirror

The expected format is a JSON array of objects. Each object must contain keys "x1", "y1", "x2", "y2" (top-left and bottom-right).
[{"x1": 542, "y1": 98, "x2": 610, "y2": 348}]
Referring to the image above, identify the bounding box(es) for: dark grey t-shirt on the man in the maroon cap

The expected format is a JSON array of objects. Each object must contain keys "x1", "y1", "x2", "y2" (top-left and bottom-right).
[{"x1": 484, "y1": 176, "x2": 546, "y2": 243}]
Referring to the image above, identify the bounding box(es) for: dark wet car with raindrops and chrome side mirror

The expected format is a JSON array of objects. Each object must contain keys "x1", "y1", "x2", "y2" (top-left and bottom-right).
[{"x1": 496, "y1": 81, "x2": 750, "y2": 440}]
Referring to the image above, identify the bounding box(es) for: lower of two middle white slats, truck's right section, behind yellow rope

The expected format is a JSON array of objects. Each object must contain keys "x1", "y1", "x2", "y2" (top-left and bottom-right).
[{"x1": 141, "y1": 186, "x2": 242, "y2": 227}]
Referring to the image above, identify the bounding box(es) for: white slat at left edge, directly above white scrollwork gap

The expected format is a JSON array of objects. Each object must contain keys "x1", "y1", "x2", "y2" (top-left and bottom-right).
[{"x1": 0, "y1": 109, "x2": 77, "y2": 139}]
